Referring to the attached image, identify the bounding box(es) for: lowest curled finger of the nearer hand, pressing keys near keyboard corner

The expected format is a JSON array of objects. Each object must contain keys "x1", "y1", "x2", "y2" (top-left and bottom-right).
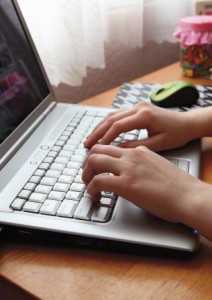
[{"x1": 87, "y1": 174, "x2": 123, "y2": 201}]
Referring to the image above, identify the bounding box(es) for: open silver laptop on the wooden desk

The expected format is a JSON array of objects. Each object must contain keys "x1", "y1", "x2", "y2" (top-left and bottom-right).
[{"x1": 0, "y1": 0, "x2": 200, "y2": 253}]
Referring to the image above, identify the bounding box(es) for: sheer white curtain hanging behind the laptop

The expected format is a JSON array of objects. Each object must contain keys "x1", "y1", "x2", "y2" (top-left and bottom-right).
[{"x1": 18, "y1": 0, "x2": 192, "y2": 86}]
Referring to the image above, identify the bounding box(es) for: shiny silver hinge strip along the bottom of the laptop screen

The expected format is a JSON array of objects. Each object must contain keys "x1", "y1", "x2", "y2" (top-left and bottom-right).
[{"x1": 0, "y1": 102, "x2": 56, "y2": 170}]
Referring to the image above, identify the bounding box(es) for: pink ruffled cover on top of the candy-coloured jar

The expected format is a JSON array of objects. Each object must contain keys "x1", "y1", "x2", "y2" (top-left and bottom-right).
[{"x1": 174, "y1": 15, "x2": 212, "y2": 46}]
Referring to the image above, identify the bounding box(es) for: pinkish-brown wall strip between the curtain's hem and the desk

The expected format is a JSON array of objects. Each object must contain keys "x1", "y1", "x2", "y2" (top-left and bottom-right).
[{"x1": 54, "y1": 42, "x2": 179, "y2": 103}]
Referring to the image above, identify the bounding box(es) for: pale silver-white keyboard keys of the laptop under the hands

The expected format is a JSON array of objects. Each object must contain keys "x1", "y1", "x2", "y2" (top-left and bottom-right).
[{"x1": 11, "y1": 110, "x2": 189, "y2": 223}]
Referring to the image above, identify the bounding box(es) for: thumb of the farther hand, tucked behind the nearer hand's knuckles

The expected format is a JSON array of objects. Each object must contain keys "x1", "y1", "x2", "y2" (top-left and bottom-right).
[{"x1": 119, "y1": 133, "x2": 164, "y2": 151}]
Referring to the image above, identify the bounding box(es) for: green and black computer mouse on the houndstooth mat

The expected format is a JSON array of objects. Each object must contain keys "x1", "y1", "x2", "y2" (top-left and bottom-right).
[{"x1": 150, "y1": 80, "x2": 199, "y2": 108}]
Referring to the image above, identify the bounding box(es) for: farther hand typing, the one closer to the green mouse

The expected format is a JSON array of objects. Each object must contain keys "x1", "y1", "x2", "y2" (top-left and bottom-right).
[{"x1": 84, "y1": 102, "x2": 193, "y2": 151}]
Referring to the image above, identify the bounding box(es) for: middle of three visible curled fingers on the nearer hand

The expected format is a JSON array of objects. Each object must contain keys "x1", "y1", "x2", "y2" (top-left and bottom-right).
[{"x1": 82, "y1": 154, "x2": 121, "y2": 184}]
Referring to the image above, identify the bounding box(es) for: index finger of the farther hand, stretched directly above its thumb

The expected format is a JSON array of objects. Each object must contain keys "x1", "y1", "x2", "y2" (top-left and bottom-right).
[{"x1": 101, "y1": 115, "x2": 139, "y2": 145}]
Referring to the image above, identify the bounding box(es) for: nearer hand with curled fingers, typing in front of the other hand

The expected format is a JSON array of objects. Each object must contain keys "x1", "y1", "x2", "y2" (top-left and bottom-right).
[{"x1": 82, "y1": 145, "x2": 203, "y2": 223}]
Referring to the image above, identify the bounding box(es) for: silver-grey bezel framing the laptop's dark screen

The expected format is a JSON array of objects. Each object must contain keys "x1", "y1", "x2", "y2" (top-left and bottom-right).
[{"x1": 0, "y1": 0, "x2": 55, "y2": 169}]
